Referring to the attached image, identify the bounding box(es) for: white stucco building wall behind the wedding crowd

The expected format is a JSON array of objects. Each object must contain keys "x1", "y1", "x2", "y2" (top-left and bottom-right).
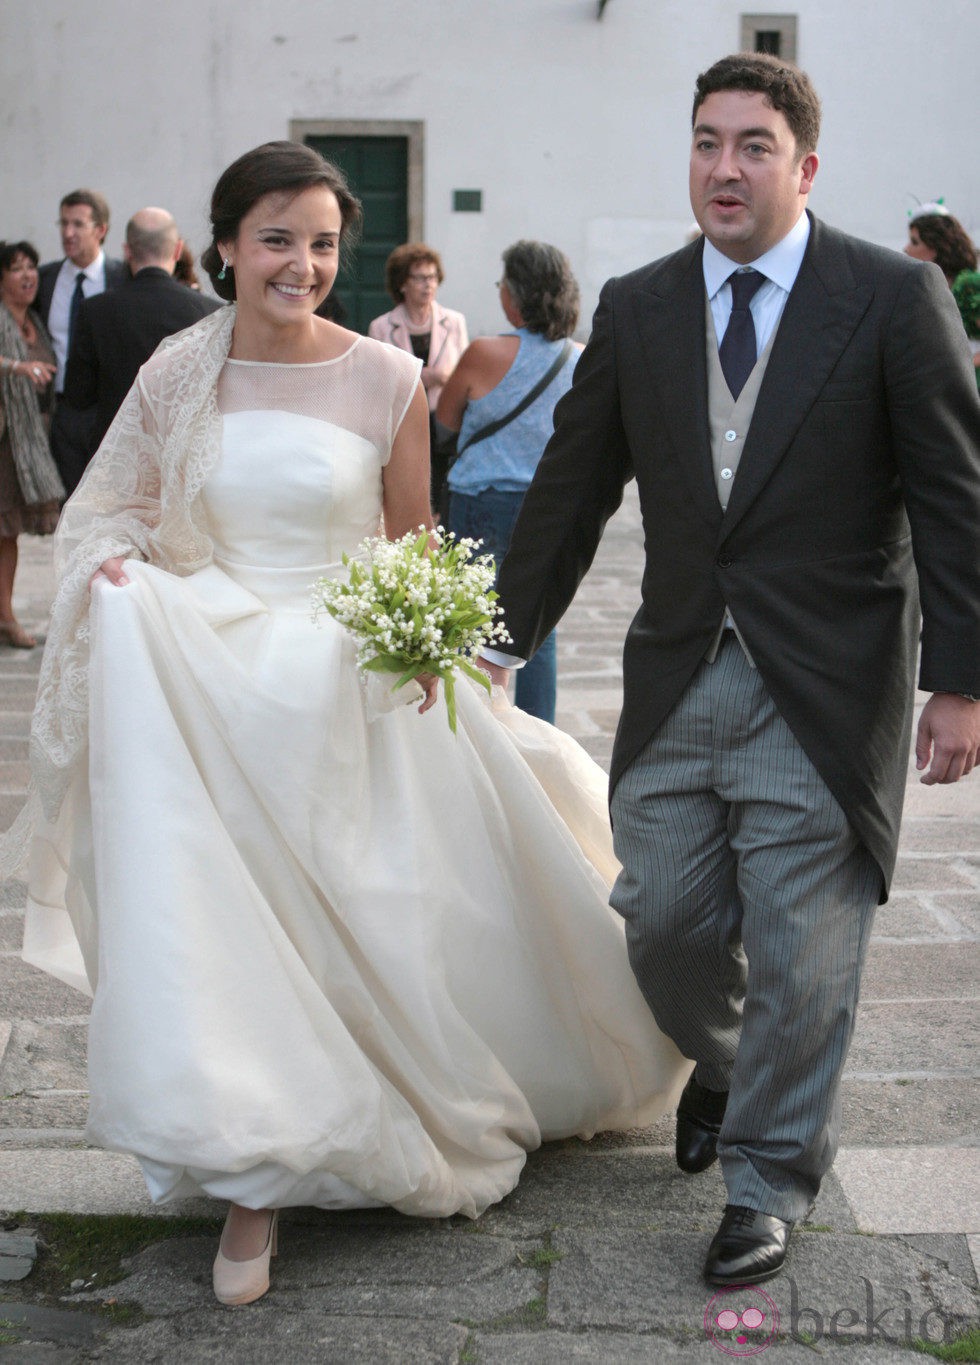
[{"x1": 0, "y1": 0, "x2": 980, "y2": 333}]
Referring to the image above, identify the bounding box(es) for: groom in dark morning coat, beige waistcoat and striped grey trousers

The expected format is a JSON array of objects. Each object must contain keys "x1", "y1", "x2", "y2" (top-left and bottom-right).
[{"x1": 485, "y1": 53, "x2": 980, "y2": 1284}]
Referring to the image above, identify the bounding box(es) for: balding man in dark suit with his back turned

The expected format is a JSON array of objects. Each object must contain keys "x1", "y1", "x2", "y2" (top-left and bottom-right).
[{"x1": 64, "y1": 209, "x2": 221, "y2": 463}]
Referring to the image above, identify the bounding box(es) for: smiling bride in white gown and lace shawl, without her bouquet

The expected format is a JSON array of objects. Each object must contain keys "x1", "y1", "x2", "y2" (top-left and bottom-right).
[{"x1": 5, "y1": 142, "x2": 689, "y2": 1304}]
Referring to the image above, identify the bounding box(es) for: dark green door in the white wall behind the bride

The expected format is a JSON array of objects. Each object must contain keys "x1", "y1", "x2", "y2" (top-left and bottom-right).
[{"x1": 303, "y1": 134, "x2": 408, "y2": 332}]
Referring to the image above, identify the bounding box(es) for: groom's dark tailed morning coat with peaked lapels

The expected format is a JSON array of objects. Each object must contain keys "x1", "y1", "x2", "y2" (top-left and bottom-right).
[{"x1": 498, "y1": 212, "x2": 980, "y2": 893}]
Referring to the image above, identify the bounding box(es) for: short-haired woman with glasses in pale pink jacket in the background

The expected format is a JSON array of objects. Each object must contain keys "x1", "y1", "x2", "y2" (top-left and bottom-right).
[{"x1": 367, "y1": 242, "x2": 470, "y2": 515}]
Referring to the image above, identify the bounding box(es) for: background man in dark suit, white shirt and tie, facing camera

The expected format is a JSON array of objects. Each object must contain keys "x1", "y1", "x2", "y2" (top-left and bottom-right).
[{"x1": 37, "y1": 190, "x2": 128, "y2": 493}]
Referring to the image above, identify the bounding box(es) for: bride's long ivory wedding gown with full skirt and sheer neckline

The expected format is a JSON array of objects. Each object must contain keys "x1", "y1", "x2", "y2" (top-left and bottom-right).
[{"x1": 26, "y1": 343, "x2": 688, "y2": 1216}]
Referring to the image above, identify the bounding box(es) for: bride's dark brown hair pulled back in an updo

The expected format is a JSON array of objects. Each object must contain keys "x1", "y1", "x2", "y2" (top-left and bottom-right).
[{"x1": 201, "y1": 142, "x2": 360, "y2": 303}]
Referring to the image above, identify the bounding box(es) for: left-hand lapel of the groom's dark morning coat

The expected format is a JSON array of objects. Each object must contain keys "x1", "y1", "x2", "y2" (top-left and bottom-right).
[{"x1": 635, "y1": 242, "x2": 721, "y2": 524}]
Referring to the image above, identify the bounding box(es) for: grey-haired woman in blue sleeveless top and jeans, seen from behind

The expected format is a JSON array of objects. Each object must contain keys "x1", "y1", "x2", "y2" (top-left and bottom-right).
[{"x1": 437, "y1": 242, "x2": 581, "y2": 723}]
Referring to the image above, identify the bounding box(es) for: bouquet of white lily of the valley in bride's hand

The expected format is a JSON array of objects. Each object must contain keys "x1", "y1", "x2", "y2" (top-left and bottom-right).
[{"x1": 313, "y1": 527, "x2": 510, "y2": 733}]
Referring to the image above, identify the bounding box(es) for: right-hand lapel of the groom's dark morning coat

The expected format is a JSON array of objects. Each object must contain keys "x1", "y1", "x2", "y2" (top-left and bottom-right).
[{"x1": 722, "y1": 220, "x2": 874, "y2": 538}]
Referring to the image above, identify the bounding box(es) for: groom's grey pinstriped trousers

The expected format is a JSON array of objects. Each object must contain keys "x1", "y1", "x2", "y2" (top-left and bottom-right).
[{"x1": 611, "y1": 631, "x2": 880, "y2": 1220}]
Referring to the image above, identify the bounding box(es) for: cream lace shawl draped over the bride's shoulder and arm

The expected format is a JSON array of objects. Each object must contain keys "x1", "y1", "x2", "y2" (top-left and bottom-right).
[{"x1": 0, "y1": 306, "x2": 236, "y2": 878}]
